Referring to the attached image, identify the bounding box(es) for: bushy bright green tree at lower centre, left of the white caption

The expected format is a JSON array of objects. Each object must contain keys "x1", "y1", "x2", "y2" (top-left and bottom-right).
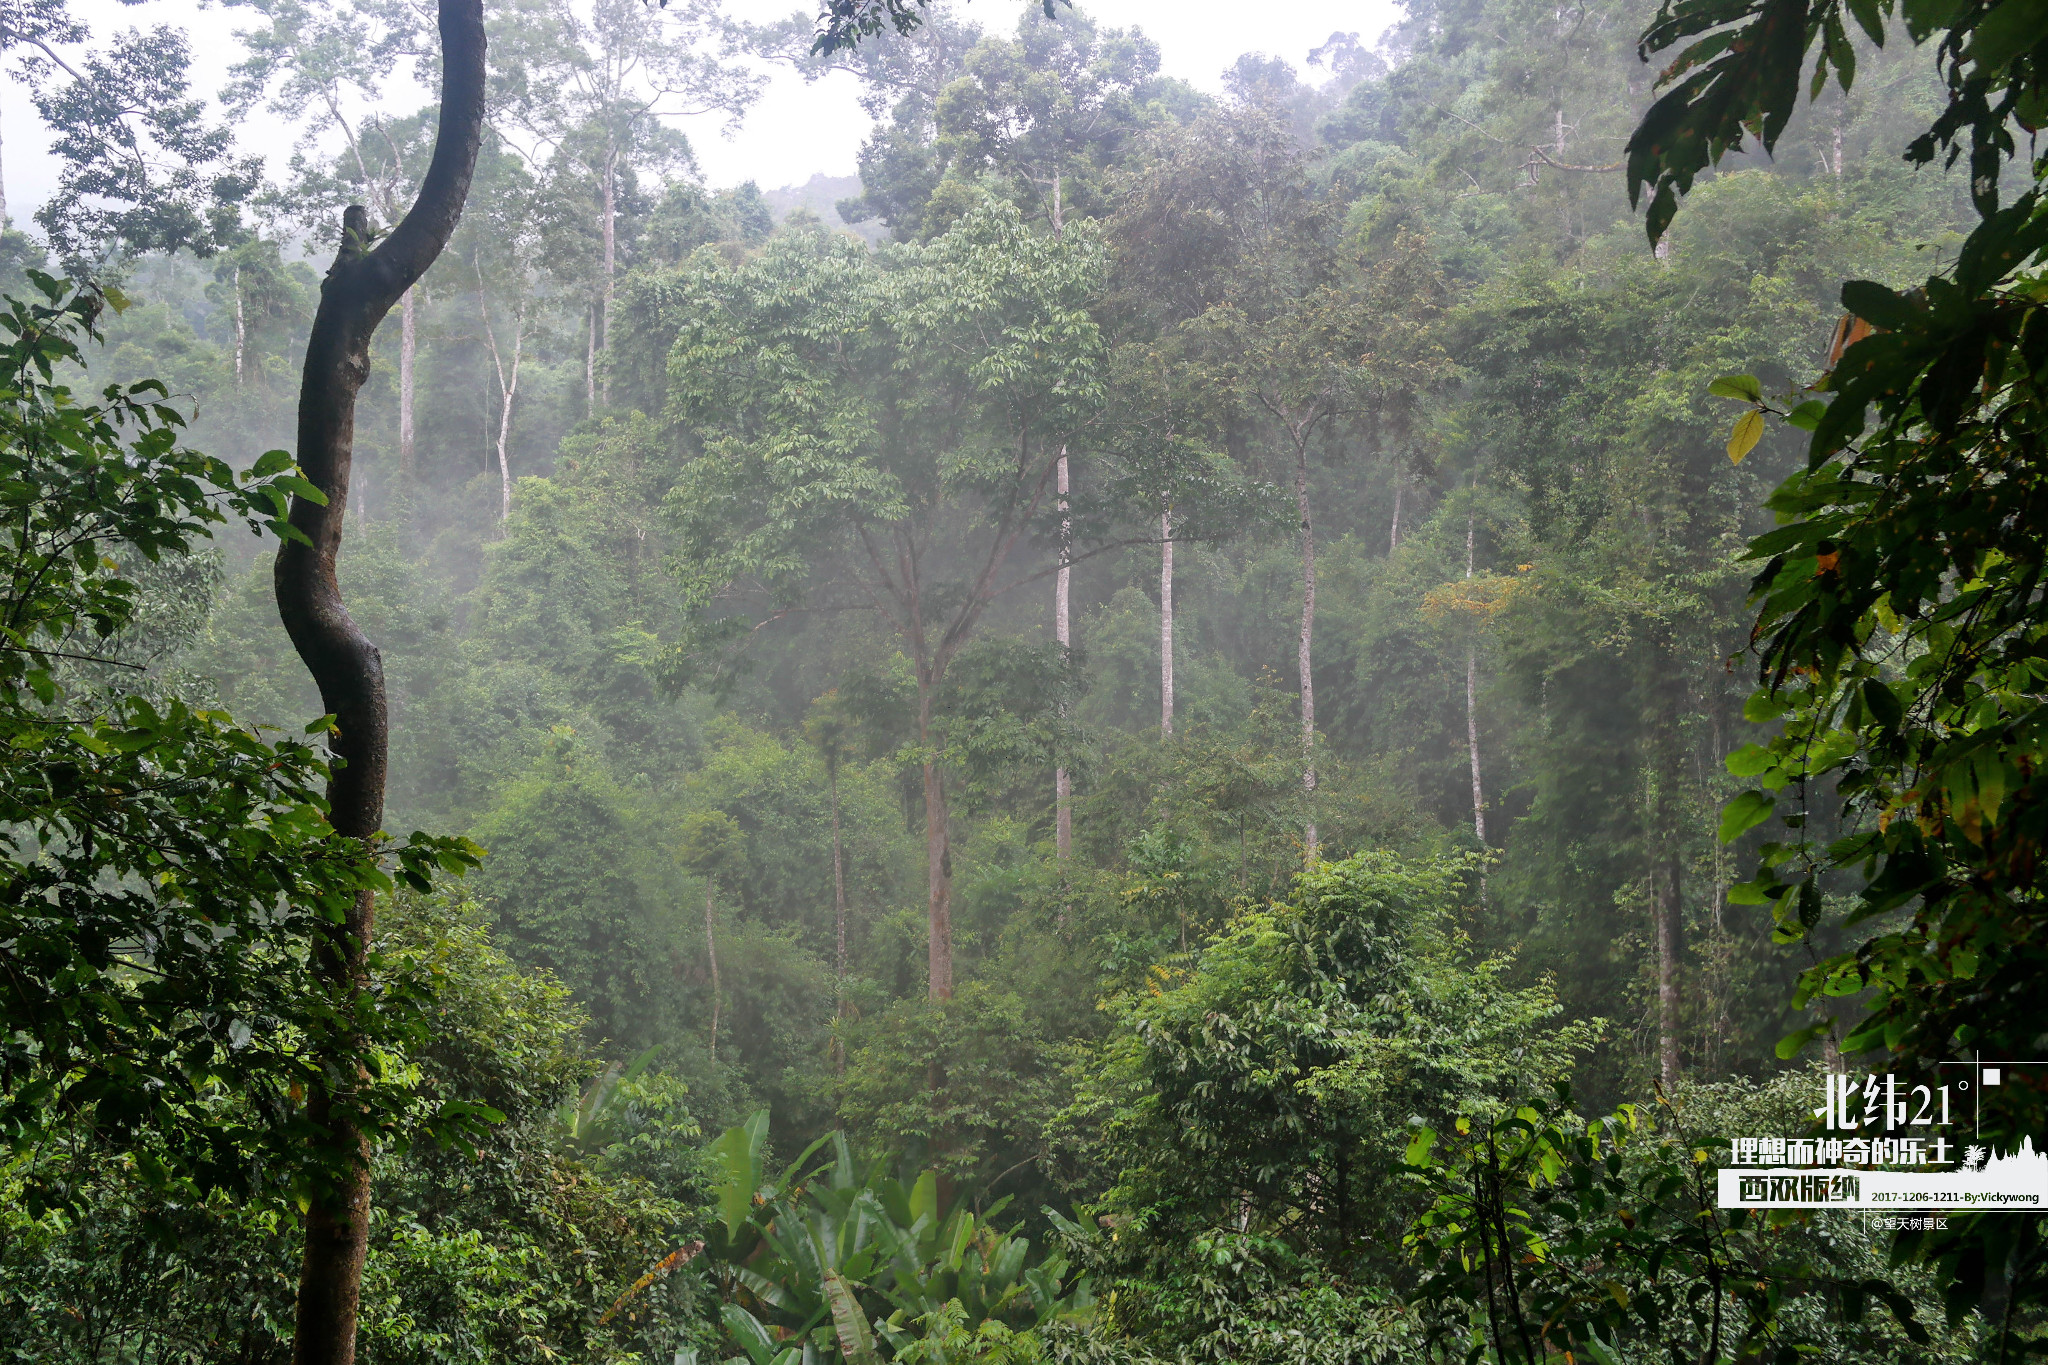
[{"x1": 1055, "y1": 853, "x2": 1593, "y2": 1357}]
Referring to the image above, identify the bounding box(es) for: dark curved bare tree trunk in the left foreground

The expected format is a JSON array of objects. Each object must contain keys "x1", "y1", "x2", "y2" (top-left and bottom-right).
[{"x1": 274, "y1": 0, "x2": 483, "y2": 1365}]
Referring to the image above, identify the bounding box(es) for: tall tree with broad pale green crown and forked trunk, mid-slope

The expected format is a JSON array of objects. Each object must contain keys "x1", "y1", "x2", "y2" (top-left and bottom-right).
[{"x1": 670, "y1": 205, "x2": 1102, "y2": 999}]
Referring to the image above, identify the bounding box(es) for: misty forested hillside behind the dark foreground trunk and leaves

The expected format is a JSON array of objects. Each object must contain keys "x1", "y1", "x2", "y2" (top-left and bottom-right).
[{"x1": 0, "y1": 0, "x2": 2015, "y2": 1365}]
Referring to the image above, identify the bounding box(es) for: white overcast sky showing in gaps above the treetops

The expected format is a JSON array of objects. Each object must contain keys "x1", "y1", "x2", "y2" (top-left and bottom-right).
[{"x1": 0, "y1": 0, "x2": 1395, "y2": 223}]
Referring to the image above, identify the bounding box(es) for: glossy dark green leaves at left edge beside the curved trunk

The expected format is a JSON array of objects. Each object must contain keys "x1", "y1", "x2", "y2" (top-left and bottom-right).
[{"x1": 0, "y1": 276, "x2": 473, "y2": 1203}]
